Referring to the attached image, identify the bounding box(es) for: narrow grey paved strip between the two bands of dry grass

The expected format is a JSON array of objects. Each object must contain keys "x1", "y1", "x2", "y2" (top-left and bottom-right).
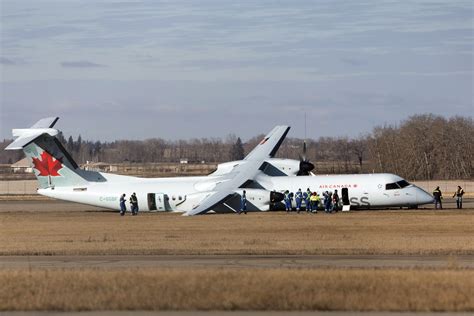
[{"x1": 0, "y1": 255, "x2": 474, "y2": 269}]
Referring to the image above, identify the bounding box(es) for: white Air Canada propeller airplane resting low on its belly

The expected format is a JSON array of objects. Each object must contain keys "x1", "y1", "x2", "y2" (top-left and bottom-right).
[{"x1": 5, "y1": 117, "x2": 433, "y2": 215}]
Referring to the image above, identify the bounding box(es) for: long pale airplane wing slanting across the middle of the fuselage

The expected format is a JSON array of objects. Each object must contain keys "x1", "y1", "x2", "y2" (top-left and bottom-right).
[{"x1": 185, "y1": 126, "x2": 290, "y2": 215}]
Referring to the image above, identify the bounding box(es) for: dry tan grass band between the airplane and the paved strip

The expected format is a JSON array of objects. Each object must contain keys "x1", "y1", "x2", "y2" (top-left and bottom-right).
[{"x1": 0, "y1": 210, "x2": 474, "y2": 255}]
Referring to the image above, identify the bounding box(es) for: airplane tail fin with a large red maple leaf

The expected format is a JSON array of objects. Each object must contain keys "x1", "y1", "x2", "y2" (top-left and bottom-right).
[{"x1": 5, "y1": 117, "x2": 105, "y2": 189}]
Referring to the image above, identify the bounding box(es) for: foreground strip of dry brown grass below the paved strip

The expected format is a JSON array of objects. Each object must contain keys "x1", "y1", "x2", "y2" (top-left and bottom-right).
[{"x1": 0, "y1": 268, "x2": 474, "y2": 311}]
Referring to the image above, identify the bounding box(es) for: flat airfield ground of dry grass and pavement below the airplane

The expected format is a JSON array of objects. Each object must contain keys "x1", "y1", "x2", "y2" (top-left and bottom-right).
[{"x1": 0, "y1": 200, "x2": 474, "y2": 312}]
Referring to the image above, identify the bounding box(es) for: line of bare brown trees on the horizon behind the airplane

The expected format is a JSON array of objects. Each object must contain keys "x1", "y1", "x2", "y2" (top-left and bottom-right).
[{"x1": 0, "y1": 114, "x2": 474, "y2": 180}]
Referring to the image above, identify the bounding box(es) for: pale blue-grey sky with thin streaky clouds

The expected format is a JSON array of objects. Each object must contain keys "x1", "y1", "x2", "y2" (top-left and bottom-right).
[{"x1": 0, "y1": 0, "x2": 474, "y2": 140}]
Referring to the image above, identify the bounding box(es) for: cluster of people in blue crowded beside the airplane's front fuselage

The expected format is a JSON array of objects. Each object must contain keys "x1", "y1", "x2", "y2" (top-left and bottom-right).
[{"x1": 283, "y1": 188, "x2": 340, "y2": 213}]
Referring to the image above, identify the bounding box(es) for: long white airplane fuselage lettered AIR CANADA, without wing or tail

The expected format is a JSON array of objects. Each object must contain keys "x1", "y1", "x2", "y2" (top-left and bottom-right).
[{"x1": 38, "y1": 173, "x2": 432, "y2": 212}]
